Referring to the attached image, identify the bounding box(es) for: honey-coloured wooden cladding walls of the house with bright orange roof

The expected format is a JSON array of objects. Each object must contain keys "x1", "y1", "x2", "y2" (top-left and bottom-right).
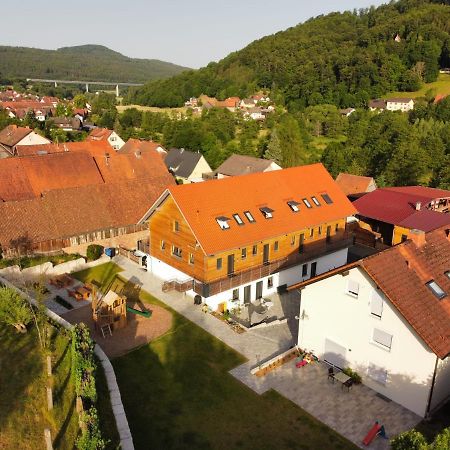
[{"x1": 149, "y1": 195, "x2": 350, "y2": 295}]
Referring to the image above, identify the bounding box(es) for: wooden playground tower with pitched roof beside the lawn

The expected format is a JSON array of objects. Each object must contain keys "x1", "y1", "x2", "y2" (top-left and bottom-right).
[{"x1": 90, "y1": 284, "x2": 127, "y2": 338}]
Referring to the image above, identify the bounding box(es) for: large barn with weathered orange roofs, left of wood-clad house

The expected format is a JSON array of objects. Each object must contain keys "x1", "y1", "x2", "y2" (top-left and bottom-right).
[{"x1": 0, "y1": 148, "x2": 175, "y2": 256}]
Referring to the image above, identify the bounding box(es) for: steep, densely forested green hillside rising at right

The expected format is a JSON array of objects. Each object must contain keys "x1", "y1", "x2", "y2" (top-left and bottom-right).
[{"x1": 128, "y1": 0, "x2": 450, "y2": 110}]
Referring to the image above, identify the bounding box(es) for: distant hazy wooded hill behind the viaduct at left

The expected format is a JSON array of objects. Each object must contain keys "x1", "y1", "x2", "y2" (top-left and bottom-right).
[{"x1": 0, "y1": 45, "x2": 186, "y2": 83}]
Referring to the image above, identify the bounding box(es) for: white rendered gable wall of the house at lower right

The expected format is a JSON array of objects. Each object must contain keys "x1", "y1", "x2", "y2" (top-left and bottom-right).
[{"x1": 298, "y1": 268, "x2": 440, "y2": 416}]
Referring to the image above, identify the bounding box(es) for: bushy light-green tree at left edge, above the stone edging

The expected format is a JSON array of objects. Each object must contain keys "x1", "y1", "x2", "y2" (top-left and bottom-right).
[{"x1": 0, "y1": 287, "x2": 32, "y2": 333}]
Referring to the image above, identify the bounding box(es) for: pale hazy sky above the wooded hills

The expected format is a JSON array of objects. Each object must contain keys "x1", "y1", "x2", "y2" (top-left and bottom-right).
[{"x1": 0, "y1": 0, "x2": 386, "y2": 68}]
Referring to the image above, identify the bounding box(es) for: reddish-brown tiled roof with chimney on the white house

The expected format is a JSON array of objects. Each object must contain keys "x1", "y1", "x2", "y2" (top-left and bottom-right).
[{"x1": 361, "y1": 225, "x2": 450, "y2": 359}]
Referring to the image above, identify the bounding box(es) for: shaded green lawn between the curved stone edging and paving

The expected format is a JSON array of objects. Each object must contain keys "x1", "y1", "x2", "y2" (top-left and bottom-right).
[{"x1": 75, "y1": 263, "x2": 356, "y2": 450}]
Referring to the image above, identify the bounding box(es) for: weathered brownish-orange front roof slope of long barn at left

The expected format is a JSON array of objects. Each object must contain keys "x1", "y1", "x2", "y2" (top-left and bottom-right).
[{"x1": 0, "y1": 176, "x2": 174, "y2": 248}]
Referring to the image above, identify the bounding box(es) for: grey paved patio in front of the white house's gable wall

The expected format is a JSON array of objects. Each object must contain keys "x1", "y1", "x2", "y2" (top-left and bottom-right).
[{"x1": 231, "y1": 360, "x2": 421, "y2": 450}]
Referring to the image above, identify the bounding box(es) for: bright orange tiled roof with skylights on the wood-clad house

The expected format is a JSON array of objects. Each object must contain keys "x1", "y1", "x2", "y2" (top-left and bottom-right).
[{"x1": 169, "y1": 164, "x2": 356, "y2": 255}]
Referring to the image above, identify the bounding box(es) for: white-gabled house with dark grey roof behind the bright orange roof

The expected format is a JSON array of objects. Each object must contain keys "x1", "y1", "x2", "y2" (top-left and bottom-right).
[{"x1": 164, "y1": 148, "x2": 212, "y2": 183}]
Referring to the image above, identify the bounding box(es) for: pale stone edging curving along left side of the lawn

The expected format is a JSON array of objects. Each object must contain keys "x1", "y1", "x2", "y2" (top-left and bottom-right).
[{"x1": 0, "y1": 276, "x2": 134, "y2": 450}]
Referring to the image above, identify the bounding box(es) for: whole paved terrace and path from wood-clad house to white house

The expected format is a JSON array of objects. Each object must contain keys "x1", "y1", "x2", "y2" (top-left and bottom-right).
[{"x1": 114, "y1": 256, "x2": 420, "y2": 450}]
